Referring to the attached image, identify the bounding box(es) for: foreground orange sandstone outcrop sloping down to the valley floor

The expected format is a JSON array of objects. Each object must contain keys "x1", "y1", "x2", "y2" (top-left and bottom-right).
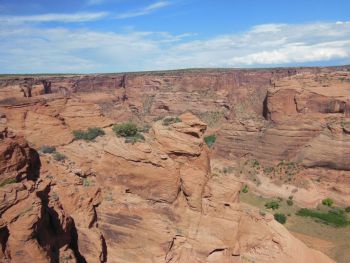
[{"x1": 0, "y1": 113, "x2": 333, "y2": 263}]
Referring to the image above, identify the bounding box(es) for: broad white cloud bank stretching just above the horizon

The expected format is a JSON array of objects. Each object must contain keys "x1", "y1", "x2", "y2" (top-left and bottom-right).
[{"x1": 0, "y1": 22, "x2": 350, "y2": 73}]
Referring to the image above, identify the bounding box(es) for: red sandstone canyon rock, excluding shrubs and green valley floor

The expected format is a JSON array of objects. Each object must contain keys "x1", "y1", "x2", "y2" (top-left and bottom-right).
[{"x1": 0, "y1": 66, "x2": 350, "y2": 262}]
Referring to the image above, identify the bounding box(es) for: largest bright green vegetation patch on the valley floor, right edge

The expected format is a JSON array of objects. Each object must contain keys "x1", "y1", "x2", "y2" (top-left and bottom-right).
[{"x1": 296, "y1": 208, "x2": 349, "y2": 227}]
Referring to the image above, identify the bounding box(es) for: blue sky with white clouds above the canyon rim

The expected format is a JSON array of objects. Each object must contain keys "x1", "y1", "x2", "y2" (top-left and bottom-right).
[{"x1": 0, "y1": 0, "x2": 350, "y2": 73}]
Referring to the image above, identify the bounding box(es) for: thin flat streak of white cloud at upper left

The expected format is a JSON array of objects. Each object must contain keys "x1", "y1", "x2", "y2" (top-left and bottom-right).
[{"x1": 0, "y1": 12, "x2": 108, "y2": 23}]
